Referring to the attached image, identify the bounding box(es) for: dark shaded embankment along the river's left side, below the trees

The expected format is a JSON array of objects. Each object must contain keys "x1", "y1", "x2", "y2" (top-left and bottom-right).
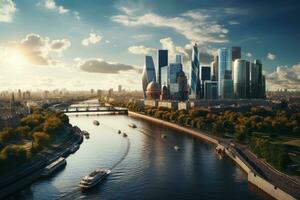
[{"x1": 0, "y1": 125, "x2": 83, "y2": 199}]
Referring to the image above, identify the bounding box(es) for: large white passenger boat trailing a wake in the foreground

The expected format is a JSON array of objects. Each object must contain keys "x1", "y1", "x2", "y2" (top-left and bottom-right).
[{"x1": 78, "y1": 169, "x2": 111, "y2": 189}]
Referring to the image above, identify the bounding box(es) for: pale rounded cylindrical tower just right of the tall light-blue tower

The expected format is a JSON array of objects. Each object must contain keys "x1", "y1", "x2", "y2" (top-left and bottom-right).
[{"x1": 233, "y1": 59, "x2": 250, "y2": 99}]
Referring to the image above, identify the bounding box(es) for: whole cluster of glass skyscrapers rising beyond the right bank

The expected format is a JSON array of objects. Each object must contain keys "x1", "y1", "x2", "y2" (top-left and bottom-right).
[{"x1": 142, "y1": 44, "x2": 265, "y2": 101}]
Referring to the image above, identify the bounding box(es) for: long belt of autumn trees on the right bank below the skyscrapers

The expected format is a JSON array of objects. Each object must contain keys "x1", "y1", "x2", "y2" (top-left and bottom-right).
[{"x1": 126, "y1": 102, "x2": 300, "y2": 169}]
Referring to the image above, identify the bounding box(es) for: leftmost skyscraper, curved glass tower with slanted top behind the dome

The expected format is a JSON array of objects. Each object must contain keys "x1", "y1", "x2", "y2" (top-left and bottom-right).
[{"x1": 142, "y1": 56, "x2": 156, "y2": 98}]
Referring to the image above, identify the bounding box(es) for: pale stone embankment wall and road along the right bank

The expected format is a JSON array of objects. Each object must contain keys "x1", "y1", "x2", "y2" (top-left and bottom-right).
[{"x1": 128, "y1": 112, "x2": 300, "y2": 200}]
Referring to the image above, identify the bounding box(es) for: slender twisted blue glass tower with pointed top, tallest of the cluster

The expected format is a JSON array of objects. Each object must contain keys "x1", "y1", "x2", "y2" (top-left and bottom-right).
[{"x1": 190, "y1": 44, "x2": 200, "y2": 99}]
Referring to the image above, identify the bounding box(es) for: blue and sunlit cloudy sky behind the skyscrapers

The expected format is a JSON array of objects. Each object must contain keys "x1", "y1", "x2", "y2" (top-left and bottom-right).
[{"x1": 0, "y1": 0, "x2": 300, "y2": 90}]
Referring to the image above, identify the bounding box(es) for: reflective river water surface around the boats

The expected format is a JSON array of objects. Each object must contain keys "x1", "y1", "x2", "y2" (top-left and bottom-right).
[{"x1": 20, "y1": 111, "x2": 270, "y2": 200}]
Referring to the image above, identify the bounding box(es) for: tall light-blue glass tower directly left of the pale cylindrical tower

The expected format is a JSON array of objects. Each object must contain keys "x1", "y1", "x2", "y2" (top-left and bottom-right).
[{"x1": 218, "y1": 48, "x2": 233, "y2": 99}]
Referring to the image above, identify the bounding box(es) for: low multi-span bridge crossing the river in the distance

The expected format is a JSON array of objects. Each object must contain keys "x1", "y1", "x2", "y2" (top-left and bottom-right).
[{"x1": 60, "y1": 104, "x2": 128, "y2": 115}]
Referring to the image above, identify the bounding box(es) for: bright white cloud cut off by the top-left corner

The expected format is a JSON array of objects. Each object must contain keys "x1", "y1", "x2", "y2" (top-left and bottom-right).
[{"x1": 0, "y1": 0, "x2": 16, "y2": 23}]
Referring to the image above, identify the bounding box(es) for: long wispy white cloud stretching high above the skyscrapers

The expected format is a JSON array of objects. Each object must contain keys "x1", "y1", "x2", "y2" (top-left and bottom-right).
[{"x1": 111, "y1": 8, "x2": 229, "y2": 44}]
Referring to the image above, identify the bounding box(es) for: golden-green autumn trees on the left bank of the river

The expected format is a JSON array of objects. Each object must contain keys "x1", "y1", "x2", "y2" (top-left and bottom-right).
[{"x1": 0, "y1": 108, "x2": 69, "y2": 172}]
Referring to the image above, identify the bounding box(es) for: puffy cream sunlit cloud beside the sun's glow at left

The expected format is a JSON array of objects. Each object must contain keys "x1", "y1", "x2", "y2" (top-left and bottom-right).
[{"x1": 17, "y1": 33, "x2": 71, "y2": 65}]
